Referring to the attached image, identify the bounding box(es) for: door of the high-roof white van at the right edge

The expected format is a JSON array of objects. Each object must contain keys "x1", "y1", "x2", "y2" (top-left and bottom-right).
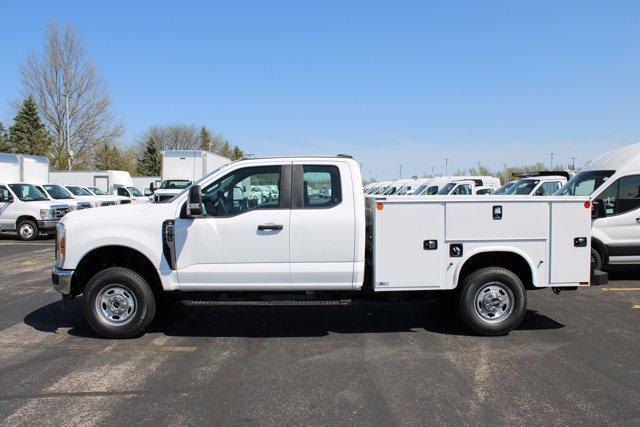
[{"x1": 593, "y1": 175, "x2": 640, "y2": 264}]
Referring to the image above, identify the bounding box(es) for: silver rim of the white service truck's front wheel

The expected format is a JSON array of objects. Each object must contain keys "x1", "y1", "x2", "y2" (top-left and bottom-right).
[{"x1": 95, "y1": 284, "x2": 138, "y2": 326}]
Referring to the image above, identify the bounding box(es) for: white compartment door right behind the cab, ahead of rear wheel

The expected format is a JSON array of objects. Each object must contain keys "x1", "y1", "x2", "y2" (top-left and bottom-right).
[{"x1": 373, "y1": 202, "x2": 446, "y2": 291}]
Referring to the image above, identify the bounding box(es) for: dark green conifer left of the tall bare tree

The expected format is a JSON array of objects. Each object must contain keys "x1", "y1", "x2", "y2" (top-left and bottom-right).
[{"x1": 9, "y1": 96, "x2": 52, "y2": 156}]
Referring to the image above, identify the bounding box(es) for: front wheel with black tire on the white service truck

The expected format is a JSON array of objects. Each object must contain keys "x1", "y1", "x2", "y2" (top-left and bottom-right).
[{"x1": 82, "y1": 267, "x2": 156, "y2": 338}]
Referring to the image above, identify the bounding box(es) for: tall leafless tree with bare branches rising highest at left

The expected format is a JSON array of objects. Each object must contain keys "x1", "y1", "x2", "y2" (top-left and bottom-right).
[{"x1": 20, "y1": 22, "x2": 124, "y2": 169}]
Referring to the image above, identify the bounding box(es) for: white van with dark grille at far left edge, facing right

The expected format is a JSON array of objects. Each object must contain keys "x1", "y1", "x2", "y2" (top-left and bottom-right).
[{"x1": 0, "y1": 183, "x2": 70, "y2": 240}]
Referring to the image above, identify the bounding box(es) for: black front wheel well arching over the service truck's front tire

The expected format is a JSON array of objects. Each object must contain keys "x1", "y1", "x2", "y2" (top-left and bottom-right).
[{"x1": 71, "y1": 246, "x2": 162, "y2": 295}]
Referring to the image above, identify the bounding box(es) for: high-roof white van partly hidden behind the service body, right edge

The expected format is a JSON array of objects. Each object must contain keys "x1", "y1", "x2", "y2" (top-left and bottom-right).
[{"x1": 556, "y1": 144, "x2": 640, "y2": 268}]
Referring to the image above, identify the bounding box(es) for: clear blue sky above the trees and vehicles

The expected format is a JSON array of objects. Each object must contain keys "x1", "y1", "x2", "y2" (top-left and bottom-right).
[{"x1": 0, "y1": 1, "x2": 640, "y2": 178}]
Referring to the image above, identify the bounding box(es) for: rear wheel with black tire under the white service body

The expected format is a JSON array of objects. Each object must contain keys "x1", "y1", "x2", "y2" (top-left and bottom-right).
[{"x1": 458, "y1": 267, "x2": 527, "y2": 335}]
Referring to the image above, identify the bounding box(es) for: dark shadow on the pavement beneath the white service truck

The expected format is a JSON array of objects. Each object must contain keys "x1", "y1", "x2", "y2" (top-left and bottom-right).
[{"x1": 24, "y1": 299, "x2": 564, "y2": 338}]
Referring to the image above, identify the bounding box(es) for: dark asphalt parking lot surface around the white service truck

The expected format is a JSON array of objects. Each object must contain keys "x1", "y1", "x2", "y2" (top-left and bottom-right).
[{"x1": 0, "y1": 234, "x2": 640, "y2": 425}]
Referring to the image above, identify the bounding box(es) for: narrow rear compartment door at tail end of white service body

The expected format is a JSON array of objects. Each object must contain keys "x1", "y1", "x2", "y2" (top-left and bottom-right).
[{"x1": 549, "y1": 201, "x2": 591, "y2": 285}]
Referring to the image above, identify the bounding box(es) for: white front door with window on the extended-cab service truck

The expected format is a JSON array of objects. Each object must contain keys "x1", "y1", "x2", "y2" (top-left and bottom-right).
[{"x1": 170, "y1": 163, "x2": 291, "y2": 290}]
